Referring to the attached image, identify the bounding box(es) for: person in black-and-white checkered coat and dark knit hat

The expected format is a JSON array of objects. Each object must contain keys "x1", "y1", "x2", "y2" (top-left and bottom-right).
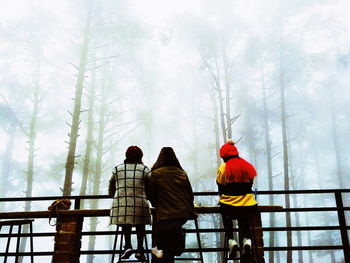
[{"x1": 108, "y1": 146, "x2": 151, "y2": 260}]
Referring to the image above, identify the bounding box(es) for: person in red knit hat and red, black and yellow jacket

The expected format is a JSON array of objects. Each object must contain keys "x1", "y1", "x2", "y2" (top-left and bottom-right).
[{"x1": 216, "y1": 140, "x2": 257, "y2": 258}]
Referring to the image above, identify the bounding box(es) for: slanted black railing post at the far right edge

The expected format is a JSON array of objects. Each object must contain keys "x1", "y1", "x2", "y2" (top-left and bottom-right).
[{"x1": 334, "y1": 191, "x2": 350, "y2": 262}]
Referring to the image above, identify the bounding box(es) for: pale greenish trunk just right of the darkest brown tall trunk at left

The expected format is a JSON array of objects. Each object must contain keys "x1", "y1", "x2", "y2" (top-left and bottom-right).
[{"x1": 80, "y1": 48, "x2": 96, "y2": 208}]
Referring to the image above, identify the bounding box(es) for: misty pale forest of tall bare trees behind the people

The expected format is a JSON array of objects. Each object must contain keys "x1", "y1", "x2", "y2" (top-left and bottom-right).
[{"x1": 0, "y1": 0, "x2": 350, "y2": 263}]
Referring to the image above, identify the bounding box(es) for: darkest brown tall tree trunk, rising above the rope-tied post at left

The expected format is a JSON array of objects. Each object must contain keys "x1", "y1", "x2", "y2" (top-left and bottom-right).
[{"x1": 63, "y1": 10, "x2": 91, "y2": 196}]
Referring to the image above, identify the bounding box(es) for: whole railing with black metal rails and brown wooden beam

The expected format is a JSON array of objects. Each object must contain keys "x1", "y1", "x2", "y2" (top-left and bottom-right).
[{"x1": 0, "y1": 189, "x2": 350, "y2": 262}]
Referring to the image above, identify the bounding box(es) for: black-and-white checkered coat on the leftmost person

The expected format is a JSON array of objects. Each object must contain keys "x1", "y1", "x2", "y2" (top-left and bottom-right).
[{"x1": 109, "y1": 164, "x2": 151, "y2": 225}]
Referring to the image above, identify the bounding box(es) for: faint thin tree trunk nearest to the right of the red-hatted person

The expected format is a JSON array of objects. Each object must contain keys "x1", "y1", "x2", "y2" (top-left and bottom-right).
[{"x1": 260, "y1": 65, "x2": 275, "y2": 263}]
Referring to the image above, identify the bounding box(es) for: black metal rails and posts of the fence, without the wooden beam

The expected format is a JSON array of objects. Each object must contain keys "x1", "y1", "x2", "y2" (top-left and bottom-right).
[{"x1": 0, "y1": 189, "x2": 350, "y2": 262}]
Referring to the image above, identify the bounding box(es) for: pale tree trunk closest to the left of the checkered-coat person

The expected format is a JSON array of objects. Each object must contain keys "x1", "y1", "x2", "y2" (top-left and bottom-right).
[{"x1": 87, "y1": 72, "x2": 109, "y2": 263}]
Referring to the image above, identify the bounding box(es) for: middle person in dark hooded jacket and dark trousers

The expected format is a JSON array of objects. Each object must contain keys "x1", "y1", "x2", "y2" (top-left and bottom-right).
[{"x1": 150, "y1": 147, "x2": 194, "y2": 263}]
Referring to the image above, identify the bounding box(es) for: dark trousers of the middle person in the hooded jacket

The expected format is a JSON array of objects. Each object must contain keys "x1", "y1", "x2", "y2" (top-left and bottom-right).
[{"x1": 153, "y1": 218, "x2": 186, "y2": 263}]
